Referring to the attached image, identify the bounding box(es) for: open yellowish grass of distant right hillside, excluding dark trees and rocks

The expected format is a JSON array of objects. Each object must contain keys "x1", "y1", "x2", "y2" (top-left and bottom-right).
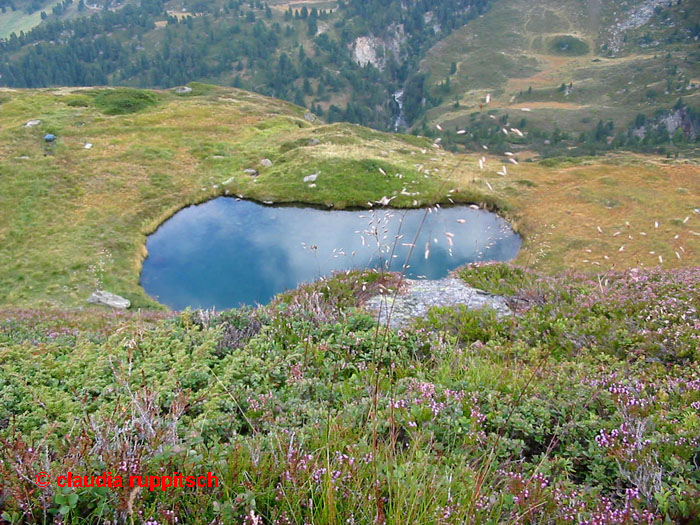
[{"x1": 421, "y1": 0, "x2": 700, "y2": 132}]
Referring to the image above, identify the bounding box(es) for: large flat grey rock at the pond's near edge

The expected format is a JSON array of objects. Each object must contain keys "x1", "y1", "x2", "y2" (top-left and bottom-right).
[{"x1": 365, "y1": 277, "x2": 512, "y2": 328}]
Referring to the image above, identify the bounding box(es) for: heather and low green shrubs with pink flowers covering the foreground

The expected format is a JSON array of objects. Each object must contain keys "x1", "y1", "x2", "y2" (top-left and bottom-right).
[{"x1": 0, "y1": 264, "x2": 700, "y2": 524}]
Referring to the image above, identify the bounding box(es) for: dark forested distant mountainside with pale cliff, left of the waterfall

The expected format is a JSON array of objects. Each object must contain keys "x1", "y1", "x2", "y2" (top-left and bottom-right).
[{"x1": 0, "y1": 0, "x2": 487, "y2": 129}]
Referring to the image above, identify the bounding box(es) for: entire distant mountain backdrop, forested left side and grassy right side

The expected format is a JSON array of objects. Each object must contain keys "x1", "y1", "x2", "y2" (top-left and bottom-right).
[{"x1": 0, "y1": 0, "x2": 700, "y2": 156}]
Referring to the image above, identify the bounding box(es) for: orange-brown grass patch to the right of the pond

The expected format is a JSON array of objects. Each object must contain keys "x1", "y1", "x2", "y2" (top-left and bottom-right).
[{"x1": 458, "y1": 155, "x2": 700, "y2": 272}]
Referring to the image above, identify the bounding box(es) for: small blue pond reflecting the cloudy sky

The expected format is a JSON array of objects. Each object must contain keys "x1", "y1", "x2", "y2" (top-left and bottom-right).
[{"x1": 141, "y1": 197, "x2": 521, "y2": 310}]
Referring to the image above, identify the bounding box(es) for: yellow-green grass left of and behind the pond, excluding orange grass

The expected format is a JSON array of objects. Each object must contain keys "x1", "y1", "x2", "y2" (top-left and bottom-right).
[{"x1": 0, "y1": 86, "x2": 476, "y2": 307}]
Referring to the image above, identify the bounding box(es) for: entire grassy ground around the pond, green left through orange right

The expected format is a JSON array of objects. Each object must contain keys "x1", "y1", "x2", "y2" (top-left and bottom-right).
[{"x1": 0, "y1": 86, "x2": 700, "y2": 306}]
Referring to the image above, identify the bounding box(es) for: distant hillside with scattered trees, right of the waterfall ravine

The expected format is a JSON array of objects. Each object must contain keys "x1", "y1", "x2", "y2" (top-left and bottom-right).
[{"x1": 417, "y1": 0, "x2": 700, "y2": 154}]
